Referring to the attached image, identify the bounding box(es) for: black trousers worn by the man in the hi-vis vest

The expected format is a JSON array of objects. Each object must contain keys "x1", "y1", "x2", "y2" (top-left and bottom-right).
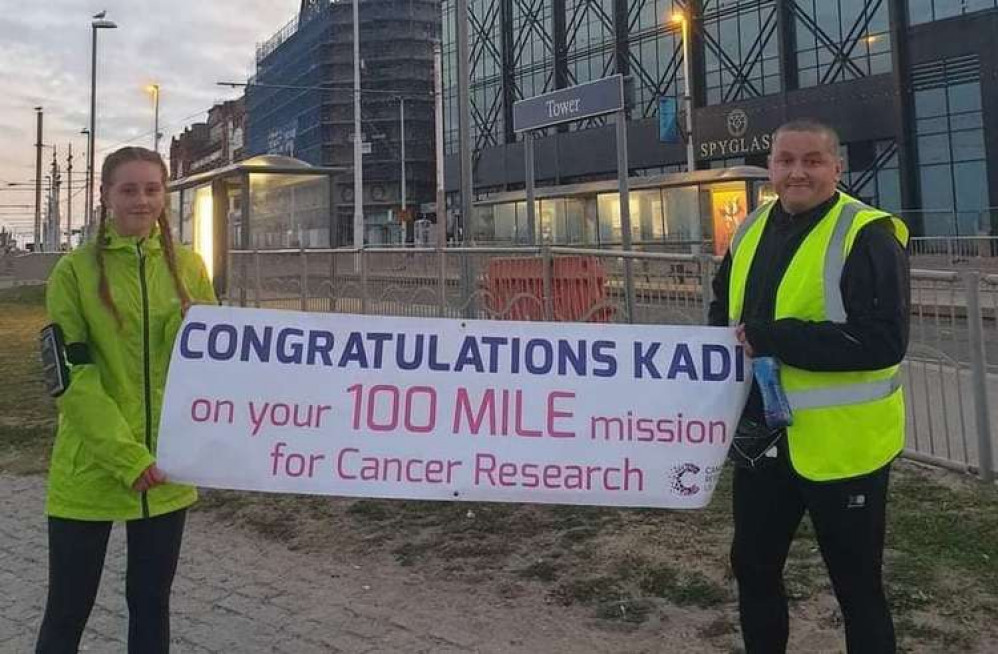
[{"x1": 731, "y1": 452, "x2": 896, "y2": 654}]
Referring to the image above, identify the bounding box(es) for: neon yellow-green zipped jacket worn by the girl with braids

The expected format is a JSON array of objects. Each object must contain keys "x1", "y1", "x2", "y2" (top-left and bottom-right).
[{"x1": 46, "y1": 227, "x2": 216, "y2": 520}]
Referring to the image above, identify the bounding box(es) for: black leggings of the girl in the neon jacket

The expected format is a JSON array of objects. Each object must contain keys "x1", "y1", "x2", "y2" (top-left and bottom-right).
[{"x1": 35, "y1": 510, "x2": 187, "y2": 654}]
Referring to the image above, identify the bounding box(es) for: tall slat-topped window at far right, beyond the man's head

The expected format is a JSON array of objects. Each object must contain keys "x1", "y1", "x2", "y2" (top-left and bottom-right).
[{"x1": 911, "y1": 55, "x2": 989, "y2": 236}]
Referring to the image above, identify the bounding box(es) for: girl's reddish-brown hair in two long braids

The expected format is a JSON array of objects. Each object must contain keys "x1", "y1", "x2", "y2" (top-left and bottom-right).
[{"x1": 97, "y1": 146, "x2": 191, "y2": 327}]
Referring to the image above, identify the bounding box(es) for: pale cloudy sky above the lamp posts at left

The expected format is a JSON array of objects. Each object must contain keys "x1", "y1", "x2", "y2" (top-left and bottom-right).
[{"x1": 0, "y1": 0, "x2": 300, "y2": 241}]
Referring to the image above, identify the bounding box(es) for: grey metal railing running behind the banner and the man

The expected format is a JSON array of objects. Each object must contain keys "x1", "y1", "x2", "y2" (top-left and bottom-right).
[{"x1": 227, "y1": 247, "x2": 998, "y2": 482}]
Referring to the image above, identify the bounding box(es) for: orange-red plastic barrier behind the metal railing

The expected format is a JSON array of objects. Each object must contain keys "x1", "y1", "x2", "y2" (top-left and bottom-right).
[{"x1": 486, "y1": 256, "x2": 613, "y2": 322}]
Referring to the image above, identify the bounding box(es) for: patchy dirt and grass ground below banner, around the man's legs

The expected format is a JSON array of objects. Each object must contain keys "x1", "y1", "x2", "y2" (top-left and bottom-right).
[{"x1": 200, "y1": 463, "x2": 998, "y2": 652}]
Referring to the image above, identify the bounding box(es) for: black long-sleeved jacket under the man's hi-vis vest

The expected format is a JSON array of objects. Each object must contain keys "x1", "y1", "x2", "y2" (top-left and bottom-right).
[{"x1": 710, "y1": 193, "x2": 911, "y2": 419}]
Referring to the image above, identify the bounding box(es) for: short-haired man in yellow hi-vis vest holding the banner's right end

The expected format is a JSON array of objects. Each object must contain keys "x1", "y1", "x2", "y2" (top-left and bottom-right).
[{"x1": 710, "y1": 120, "x2": 910, "y2": 654}]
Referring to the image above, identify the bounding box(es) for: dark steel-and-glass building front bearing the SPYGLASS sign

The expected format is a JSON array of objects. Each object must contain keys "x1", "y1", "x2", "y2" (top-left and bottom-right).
[{"x1": 443, "y1": 0, "x2": 998, "y2": 236}]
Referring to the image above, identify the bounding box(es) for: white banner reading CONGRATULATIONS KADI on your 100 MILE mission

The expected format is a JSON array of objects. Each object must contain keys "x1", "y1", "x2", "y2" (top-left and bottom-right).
[{"x1": 157, "y1": 306, "x2": 751, "y2": 508}]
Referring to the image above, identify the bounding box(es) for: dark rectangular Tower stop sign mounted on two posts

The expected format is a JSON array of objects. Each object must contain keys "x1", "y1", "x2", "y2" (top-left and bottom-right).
[{"x1": 513, "y1": 75, "x2": 624, "y2": 132}]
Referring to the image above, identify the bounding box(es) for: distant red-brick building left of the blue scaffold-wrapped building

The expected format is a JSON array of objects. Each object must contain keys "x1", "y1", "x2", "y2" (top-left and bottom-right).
[{"x1": 170, "y1": 98, "x2": 246, "y2": 179}]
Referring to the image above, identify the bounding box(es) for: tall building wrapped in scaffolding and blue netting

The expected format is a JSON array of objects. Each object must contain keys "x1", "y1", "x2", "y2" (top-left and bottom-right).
[{"x1": 246, "y1": 0, "x2": 440, "y2": 244}]
